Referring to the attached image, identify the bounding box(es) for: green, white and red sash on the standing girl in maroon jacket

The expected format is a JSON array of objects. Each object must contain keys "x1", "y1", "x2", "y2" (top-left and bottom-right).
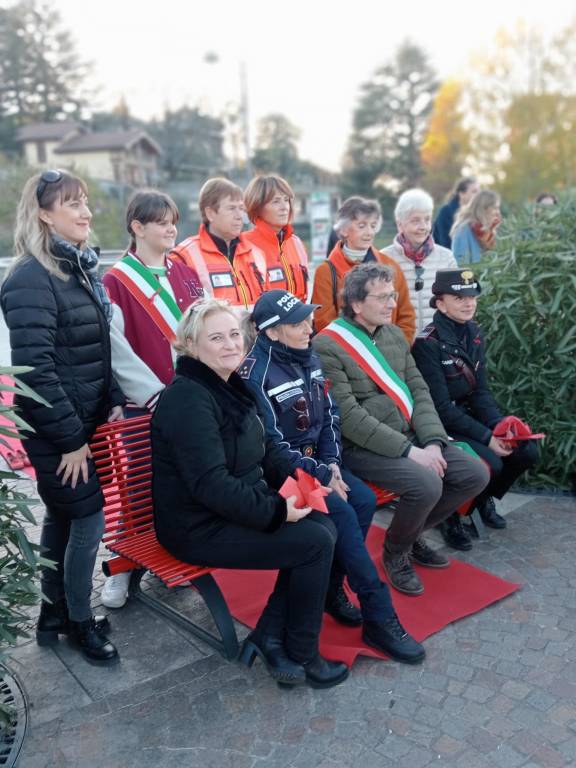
[{"x1": 110, "y1": 253, "x2": 182, "y2": 342}]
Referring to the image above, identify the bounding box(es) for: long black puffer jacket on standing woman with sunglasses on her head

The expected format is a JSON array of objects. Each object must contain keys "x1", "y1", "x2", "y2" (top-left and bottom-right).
[{"x1": 1, "y1": 257, "x2": 124, "y2": 518}]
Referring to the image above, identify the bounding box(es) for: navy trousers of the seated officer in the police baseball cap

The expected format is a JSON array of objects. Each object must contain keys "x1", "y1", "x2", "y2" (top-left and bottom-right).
[{"x1": 326, "y1": 469, "x2": 394, "y2": 621}]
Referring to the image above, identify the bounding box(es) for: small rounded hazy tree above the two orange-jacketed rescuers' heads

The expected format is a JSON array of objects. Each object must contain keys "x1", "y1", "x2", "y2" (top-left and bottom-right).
[{"x1": 252, "y1": 114, "x2": 300, "y2": 178}]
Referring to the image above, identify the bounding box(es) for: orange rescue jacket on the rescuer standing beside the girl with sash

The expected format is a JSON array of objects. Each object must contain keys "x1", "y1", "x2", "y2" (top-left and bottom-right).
[{"x1": 170, "y1": 224, "x2": 266, "y2": 309}]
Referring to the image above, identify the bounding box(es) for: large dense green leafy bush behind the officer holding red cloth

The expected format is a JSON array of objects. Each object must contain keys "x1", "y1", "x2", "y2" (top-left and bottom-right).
[{"x1": 478, "y1": 196, "x2": 576, "y2": 489}]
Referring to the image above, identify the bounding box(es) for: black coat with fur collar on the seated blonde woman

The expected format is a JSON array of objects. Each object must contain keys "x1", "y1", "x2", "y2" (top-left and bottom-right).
[{"x1": 152, "y1": 357, "x2": 291, "y2": 565}]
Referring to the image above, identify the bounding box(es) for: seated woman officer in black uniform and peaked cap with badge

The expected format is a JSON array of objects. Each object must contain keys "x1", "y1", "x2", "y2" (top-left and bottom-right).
[{"x1": 412, "y1": 268, "x2": 538, "y2": 550}]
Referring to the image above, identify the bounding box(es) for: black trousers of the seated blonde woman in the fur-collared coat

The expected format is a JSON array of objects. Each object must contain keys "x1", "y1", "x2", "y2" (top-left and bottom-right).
[{"x1": 182, "y1": 512, "x2": 337, "y2": 662}]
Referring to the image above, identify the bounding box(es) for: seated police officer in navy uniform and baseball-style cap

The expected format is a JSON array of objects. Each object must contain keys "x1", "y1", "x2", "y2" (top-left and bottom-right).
[{"x1": 238, "y1": 290, "x2": 425, "y2": 664}]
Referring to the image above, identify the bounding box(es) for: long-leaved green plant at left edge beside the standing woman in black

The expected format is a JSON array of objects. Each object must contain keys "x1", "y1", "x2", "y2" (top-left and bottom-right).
[{"x1": 0, "y1": 367, "x2": 54, "y2": 723}]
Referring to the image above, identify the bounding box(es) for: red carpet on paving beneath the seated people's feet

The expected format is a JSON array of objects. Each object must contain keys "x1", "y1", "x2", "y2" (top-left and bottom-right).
[{"x1": 214, "y1": 525, "x2": 520, "y2": 665}]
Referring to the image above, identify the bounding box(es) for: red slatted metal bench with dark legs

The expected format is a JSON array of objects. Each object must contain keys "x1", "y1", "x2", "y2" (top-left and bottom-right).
[{"x1": 90, "y1": 415, "x2": 239, "y2": 659}]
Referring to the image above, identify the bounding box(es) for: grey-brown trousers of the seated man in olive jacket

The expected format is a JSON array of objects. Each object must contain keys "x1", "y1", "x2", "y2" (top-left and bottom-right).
[{"x1": 344, "y1": 445, "x2": 490, "y2": 552}]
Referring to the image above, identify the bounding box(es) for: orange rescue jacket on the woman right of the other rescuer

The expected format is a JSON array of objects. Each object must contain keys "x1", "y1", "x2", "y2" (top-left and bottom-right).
[{"x1": 246, "y1": 219, "x2": 308, "y2": 301}]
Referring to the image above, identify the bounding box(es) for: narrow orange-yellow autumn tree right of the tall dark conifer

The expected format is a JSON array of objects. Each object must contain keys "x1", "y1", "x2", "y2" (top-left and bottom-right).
[{"x1": 420, "y1": 80, "x2": 470, "y2": 201}]
